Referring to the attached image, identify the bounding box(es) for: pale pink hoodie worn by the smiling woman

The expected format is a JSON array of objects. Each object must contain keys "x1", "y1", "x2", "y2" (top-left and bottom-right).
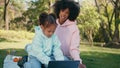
[{"x1": 55, "y1": 19, "x2": 82, "y2": 63}]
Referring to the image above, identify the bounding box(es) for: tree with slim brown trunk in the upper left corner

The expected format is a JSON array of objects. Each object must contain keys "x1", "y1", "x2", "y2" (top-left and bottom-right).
[{"x1": 3, "y1": 0, "x2": 25, "y2": 30}]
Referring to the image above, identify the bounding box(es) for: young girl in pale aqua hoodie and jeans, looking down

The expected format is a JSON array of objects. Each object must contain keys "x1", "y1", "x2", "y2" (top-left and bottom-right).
[{"x1": 24, "y1": 13, "x2": 64, "y2": 68}]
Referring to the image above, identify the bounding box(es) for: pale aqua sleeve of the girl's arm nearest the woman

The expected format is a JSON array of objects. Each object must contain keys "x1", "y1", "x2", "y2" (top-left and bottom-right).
[{"x1": 53, "y1": 36, "x2": 64, "y2": 60}]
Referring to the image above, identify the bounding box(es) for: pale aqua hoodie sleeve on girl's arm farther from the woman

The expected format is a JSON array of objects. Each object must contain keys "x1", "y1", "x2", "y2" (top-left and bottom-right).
[{"x1": 32, "y1": 33, "x2": 51, "y2": 65}]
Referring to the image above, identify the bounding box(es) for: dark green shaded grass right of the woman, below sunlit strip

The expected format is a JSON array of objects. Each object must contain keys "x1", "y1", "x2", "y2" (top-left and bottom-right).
[{"x1": 81, "y1": 51, "x2": 120, "y2": 68}]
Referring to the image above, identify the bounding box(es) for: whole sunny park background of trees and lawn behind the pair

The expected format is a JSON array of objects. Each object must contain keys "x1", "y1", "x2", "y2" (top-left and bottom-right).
[{"x1": 0, "y1": 0, "x2": 120, "y2": 68}]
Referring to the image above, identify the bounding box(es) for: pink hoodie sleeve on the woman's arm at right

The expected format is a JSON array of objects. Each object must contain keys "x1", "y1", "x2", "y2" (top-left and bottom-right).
[{"x1": 70, "y1": 30, "x2": 82, "y2": 63}]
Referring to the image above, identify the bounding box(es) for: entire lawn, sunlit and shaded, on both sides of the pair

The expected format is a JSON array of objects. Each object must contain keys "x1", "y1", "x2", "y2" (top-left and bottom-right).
[{"x1": 0, "y1": 40, "x2": 120, "y2": 68}]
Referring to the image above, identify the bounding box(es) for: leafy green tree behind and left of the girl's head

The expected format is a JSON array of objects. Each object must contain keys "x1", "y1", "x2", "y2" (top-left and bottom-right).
[{"x1": 9, "y1": 0, "x2": 49, "y2": 31}]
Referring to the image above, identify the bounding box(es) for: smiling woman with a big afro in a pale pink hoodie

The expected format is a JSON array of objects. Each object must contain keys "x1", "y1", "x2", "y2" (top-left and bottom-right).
[{"x1": 53, "y1": 0, "x2": 85, "y2": 68}]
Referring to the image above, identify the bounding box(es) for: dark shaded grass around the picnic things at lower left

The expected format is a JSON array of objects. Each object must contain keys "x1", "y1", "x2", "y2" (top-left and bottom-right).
[{"x1": 0, "y1": 49, "x2": 27, "y2": 68}]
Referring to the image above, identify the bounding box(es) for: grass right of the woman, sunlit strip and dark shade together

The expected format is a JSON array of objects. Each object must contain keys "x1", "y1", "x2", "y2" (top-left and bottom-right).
[{"x1": 81, "y1": 45, "x2": 120, "y2": 68}]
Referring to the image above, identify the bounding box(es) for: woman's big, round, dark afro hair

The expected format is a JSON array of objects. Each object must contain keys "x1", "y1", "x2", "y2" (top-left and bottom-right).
[{"x1": 53, "y1": 0, "x2": 80, "y2": 21}]
